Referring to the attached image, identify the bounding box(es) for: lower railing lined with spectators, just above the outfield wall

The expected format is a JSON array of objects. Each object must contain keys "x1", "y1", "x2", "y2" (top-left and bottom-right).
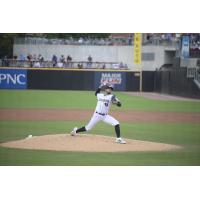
[{"x1": 0, "y1": 59, "x2": 128, "y2": 70}]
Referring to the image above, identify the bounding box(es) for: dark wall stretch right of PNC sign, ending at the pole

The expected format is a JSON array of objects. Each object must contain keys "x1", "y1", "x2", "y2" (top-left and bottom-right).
[{"x1": 27, "y1": 70, "x2": 139, "y2": 91}]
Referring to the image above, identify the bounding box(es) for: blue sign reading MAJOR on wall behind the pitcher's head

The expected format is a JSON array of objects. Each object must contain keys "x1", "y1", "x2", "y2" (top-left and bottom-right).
[{"x1": 94, "y1": 72, "x2": 126, "y2": 91}]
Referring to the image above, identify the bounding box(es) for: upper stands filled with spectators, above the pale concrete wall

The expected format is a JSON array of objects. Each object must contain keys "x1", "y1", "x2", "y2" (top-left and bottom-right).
[{"x1": 14, "y1": 33, "x2": 180, "y2": 46}]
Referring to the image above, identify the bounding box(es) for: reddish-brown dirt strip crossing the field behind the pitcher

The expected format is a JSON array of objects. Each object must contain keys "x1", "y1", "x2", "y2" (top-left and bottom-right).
[{"x1": 0, "y1": 109, "x2": 200, "y2": 123}]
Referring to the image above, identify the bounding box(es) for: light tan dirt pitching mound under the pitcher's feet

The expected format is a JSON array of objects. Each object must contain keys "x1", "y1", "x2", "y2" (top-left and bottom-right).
[{"x1": 1, "y1": 134, "x2": 180, "y2": 152}]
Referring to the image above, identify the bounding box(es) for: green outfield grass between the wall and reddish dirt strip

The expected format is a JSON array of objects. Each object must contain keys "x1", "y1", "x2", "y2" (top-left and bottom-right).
[{"x1": 0, "y1": 90, "x2": 200, "y2": 112}]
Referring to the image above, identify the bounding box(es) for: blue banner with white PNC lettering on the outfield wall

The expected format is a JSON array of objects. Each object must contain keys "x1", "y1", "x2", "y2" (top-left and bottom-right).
[{"x1": 0, "y1": 69, "x2": 27, "y2": 89}]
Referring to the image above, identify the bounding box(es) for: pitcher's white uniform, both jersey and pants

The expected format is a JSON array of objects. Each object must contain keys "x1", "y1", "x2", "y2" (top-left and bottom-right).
[{"x1": 85, "y1": 93, "x2": 119, "y2": 131}]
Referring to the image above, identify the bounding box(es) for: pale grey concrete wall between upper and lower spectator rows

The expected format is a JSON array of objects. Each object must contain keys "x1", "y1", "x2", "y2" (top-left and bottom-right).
[{"x1": 13, "y1": 44, "x2": 168, "y2": 71}]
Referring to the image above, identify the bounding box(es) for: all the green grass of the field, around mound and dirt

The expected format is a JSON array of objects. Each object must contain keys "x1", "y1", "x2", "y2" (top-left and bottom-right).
[{"x1": 0, "y1": 90, "x2": 200, "y2": 166}]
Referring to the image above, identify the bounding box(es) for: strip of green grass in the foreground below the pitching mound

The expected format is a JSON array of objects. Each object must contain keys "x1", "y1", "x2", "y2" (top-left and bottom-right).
[{"x1": 0, "y1": 148, "x2": 200, "y2": 166}]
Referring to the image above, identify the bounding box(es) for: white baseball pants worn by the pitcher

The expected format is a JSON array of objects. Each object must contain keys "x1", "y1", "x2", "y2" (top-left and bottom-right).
[{"x1": 85, "y1": 113, "x2": 119, "y2": 131}]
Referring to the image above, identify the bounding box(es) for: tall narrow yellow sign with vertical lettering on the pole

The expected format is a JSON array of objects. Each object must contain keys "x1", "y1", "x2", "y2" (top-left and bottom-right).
[{"x1": 134, "y1": 33, "x2": 142, "y2": 65}]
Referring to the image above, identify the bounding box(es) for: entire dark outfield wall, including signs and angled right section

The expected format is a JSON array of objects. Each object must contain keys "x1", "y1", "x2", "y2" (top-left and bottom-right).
[{"x1": 0, "y1": 67, "x2": 200, "y2": 98}]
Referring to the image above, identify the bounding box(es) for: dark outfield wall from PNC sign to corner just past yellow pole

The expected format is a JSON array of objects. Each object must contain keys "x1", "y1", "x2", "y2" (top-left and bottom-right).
[{"x1": 0, "y1": 68, "x2": 154, "y2": 92}]
